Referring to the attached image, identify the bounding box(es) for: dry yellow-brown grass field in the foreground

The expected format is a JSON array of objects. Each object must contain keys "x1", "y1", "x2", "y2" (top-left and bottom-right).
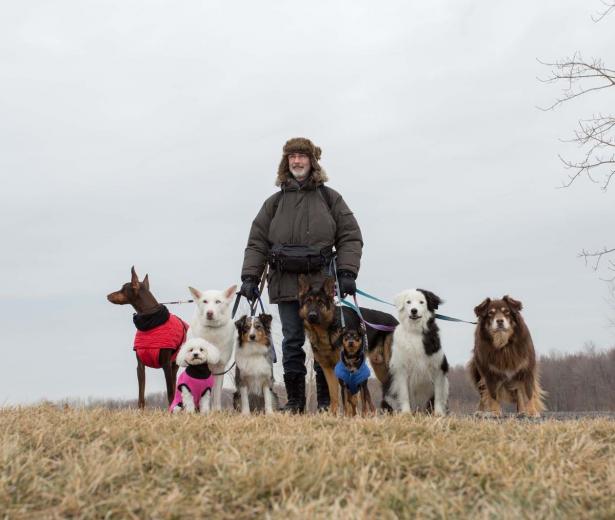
[{"x1": 0, "y1": 405, "x2": 615, "y2": 519}]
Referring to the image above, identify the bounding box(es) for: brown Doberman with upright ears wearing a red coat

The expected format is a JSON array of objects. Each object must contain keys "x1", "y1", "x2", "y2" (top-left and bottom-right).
[{"x1": 107, "y1": 266, "x2": 188, "y2": 409}]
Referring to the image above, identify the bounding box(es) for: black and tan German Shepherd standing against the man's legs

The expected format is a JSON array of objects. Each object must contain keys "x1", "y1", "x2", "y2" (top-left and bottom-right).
[{"x1": 299, "y1": 275, "x2": 398, "y2": 414}]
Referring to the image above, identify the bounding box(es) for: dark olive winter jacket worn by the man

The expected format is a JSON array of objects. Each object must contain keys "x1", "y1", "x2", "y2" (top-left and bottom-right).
[{"x1": 241, "y1": 169, "x2": 363, "y2": 303}]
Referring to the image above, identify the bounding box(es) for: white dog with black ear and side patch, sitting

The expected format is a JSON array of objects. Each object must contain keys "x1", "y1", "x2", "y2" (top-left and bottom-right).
[{"x1": 385, "y1": 289, "x2": 449, "y2": 416}]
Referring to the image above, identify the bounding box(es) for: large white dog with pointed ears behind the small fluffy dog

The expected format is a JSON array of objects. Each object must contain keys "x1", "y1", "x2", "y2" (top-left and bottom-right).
[{"x1": 188, "y1": 285, "x2": 237, "y2": 411}]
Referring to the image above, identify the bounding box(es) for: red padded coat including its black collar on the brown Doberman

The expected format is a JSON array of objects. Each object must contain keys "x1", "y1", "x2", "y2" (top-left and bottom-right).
[{"x1": 133, "y1": 305, "x2": 189, "y2": 368}]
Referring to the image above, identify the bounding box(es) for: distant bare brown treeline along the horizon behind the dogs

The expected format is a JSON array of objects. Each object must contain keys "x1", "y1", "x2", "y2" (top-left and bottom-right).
[{"x1": 74, "y1": 346, "x2": 615, "y2": 413}]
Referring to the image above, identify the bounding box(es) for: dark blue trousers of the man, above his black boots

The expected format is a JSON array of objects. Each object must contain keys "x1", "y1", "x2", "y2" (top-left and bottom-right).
[{"x1": 278, "y1": 301, "x2": 322, "y2": 376}]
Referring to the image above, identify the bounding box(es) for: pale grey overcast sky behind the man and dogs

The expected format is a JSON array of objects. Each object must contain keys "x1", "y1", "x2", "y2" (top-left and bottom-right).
[{"x1": 0, "y1": 0, "x2": 615, "y2": 404}]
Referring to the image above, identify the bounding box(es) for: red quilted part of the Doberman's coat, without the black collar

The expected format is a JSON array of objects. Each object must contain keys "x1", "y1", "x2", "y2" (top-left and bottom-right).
[{"x1": 134, "y1": 306, "x2": 189, "y2": 368}]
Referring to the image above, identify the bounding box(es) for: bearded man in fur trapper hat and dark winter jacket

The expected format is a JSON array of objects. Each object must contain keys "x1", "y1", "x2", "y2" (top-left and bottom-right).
[{"x1": 241, "y1": 137, "x2": 363, "y2": 413}]
